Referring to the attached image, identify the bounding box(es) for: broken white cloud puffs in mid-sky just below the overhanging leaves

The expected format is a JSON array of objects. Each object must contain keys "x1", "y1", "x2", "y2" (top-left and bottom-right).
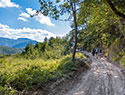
[{"x1": 19, "y1": 8, "x2": 55, "y2": 26}]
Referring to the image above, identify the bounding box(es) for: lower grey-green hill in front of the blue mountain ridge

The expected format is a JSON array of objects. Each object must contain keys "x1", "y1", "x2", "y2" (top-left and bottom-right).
[{"x1": 0, "y1": 46, "x2": 23, "y2": 55}]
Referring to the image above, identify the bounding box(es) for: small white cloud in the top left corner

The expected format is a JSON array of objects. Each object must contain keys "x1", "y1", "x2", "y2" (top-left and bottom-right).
[{"x1": 0, "y1": 0, "x2": 19, "y2": 8}]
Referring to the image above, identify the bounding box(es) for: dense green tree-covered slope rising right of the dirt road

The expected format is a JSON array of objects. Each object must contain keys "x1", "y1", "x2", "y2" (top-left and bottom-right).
[{"x1": 75, "y1": 0, "x2": 125, "y2": 64}]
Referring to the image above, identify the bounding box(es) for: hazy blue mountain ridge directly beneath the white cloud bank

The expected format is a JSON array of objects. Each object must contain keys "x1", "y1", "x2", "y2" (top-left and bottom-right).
[{"x1": 0, "y1": 37, "x2": 37, "y2": 48}]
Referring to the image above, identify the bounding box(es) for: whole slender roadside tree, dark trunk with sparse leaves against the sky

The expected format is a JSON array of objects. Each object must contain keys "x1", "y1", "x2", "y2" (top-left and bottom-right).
[{"x1": 37, "y1": 0, "x2": 82, "y2": 61}]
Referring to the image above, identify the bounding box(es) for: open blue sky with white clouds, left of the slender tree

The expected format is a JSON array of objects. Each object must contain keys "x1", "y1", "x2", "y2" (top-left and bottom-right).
[{"x1": 0, "y1": 0, "x2": 71, "y2": 42}]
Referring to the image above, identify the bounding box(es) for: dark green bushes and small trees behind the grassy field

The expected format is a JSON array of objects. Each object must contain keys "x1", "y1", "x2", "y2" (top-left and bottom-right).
[{"x1": 22, "y1": 37, "x2": 67, "y2": 59}]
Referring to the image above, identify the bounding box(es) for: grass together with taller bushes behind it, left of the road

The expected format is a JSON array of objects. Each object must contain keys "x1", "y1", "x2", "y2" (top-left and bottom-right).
[{"x1": 0, "y1": 38, "x2": 86, "y2": 95}]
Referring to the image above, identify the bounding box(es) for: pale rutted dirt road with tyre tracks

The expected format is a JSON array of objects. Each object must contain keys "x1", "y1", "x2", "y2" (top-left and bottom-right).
[{"x1": 62, "y1": 54, "x2": 125, "y2": 95}]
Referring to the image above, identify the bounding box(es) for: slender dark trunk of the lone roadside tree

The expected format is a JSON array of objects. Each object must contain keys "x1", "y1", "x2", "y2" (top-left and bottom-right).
[{"x1": 72, "y1": 10, "x2": 77, "y2": 61}]
